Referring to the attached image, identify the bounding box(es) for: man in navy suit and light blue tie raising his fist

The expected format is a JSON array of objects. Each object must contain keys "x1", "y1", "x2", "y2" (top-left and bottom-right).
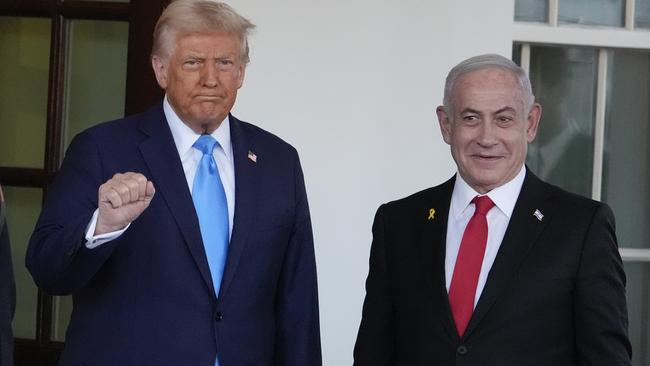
[{"x1": 27, "y1": 0, "x2": 321, "y2": 366}]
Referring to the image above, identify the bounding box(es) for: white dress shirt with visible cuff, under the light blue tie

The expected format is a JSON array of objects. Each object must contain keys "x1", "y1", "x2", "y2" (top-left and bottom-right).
[{"x1": 85, "y1": 96, "x2": 235, "y2": 249}]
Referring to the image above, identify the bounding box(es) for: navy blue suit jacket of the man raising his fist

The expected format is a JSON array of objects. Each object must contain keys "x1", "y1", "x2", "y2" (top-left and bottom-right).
[{"x1": 27, "y1": 105, "x2": 321, "y2": 366}]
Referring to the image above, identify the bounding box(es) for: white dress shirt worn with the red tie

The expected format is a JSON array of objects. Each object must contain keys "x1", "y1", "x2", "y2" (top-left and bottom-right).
[{"x1": 445, "y1": 166, "x2": 526, "y2": 307}]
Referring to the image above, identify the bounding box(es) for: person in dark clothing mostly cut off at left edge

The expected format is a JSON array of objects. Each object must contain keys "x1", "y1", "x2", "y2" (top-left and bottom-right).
[{"x1": 0, "y1": 187, "x2": 16, "y2": 366}]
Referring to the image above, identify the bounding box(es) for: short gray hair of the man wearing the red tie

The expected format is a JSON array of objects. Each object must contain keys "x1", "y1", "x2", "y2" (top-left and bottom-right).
[{"x1": 442, "y1": 54, "x2": 535, "y2": 114}]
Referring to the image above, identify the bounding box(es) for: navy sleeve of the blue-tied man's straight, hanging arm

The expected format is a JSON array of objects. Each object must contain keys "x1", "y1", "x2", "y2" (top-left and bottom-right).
[{"x1": 275, "y1": 150, "x2": 322, "y2": 366}]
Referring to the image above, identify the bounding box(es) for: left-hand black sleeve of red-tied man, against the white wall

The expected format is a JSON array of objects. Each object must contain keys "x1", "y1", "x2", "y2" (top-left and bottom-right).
[{"x1": 354, "y1": 205, "x2": 395, "y2": 366}]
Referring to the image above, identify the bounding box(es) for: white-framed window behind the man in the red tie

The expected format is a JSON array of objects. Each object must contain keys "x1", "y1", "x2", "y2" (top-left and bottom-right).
[{"x1": 513, "y1": 0, "x2": 650, "y2": 366}]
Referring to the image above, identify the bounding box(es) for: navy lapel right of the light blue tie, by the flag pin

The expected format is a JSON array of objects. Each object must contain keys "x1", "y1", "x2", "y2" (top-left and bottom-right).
[{"x1": 219, "y1": 115, "x2": 264, "y2": 298}]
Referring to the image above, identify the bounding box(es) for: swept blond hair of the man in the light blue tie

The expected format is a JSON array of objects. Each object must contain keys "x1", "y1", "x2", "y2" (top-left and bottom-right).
[{"x1": 151, "y1": 0, "x2": 255, "y2": 64}]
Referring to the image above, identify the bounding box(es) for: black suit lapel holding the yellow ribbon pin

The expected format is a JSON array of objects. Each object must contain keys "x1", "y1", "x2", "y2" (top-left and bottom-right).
[{"x1": 420, "y1": 177, "x2": 458, "y2": 341}]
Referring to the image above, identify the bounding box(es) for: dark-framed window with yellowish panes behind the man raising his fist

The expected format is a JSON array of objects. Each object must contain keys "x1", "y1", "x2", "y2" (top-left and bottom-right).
[{"x1": 0, "y1": 0, "x2": 129, "y2": 366}]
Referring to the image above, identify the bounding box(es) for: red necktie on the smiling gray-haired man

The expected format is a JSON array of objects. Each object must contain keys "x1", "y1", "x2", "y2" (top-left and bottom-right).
[{"x1": 449, "y1": 196, "x2": 494, "y2": 337}]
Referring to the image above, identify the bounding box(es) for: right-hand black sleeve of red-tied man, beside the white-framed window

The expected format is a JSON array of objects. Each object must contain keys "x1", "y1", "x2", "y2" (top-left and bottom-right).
[{"x1": 574, "y1": 204, "x2": 632, "y2": 366}]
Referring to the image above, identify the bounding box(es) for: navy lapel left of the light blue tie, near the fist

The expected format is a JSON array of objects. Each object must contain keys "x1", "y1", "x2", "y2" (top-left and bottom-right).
[{"x1": 140, "y1": 106, "x2": 214, "y2": 293}]
